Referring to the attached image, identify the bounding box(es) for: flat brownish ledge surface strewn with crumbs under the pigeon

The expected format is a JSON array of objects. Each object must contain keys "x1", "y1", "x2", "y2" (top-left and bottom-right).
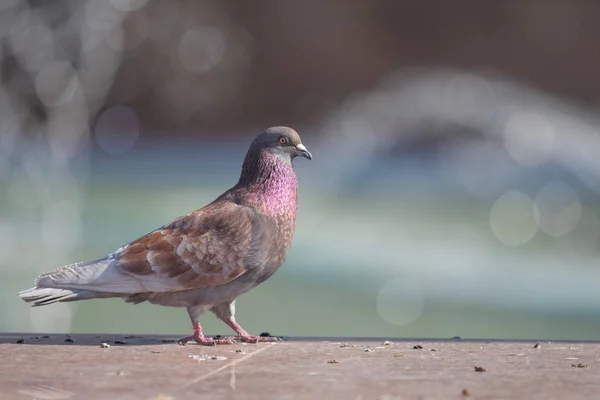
[{"x1": 0, "y1": 334, "x2": 600, "y2": 400}]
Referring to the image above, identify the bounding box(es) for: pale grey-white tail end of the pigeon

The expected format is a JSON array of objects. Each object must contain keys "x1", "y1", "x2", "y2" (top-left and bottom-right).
[{"x1": 18, "y1": 256, "x2": 123, "y2": 307}]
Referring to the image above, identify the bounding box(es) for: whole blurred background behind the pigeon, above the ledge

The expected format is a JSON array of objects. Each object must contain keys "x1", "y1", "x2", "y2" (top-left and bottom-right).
[{"x1": 0, "y1": 0, "x2": 600, "y2": 340}]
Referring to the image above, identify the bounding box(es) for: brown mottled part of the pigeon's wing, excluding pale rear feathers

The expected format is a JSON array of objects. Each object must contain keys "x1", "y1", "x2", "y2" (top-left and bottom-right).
[{"x1": 116, "y1": 202, "x2": 252, "y2": 292}]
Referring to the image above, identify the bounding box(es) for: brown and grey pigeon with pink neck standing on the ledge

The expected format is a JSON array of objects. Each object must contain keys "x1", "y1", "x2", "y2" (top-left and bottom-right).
[{"x1": 18, "y1": 126, "x2": 312, "y2": 346}]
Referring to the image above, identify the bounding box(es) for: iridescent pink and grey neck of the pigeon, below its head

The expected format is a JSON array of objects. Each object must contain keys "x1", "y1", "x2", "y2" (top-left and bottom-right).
[{"x1": 238, "y1": 150, "x2": 298, "y2": 217}]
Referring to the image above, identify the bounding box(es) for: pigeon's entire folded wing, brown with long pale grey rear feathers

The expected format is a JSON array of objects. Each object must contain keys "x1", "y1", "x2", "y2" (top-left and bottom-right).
[{"x1": 29, "y1": 202, "x2": 255, "y2": 294}]
